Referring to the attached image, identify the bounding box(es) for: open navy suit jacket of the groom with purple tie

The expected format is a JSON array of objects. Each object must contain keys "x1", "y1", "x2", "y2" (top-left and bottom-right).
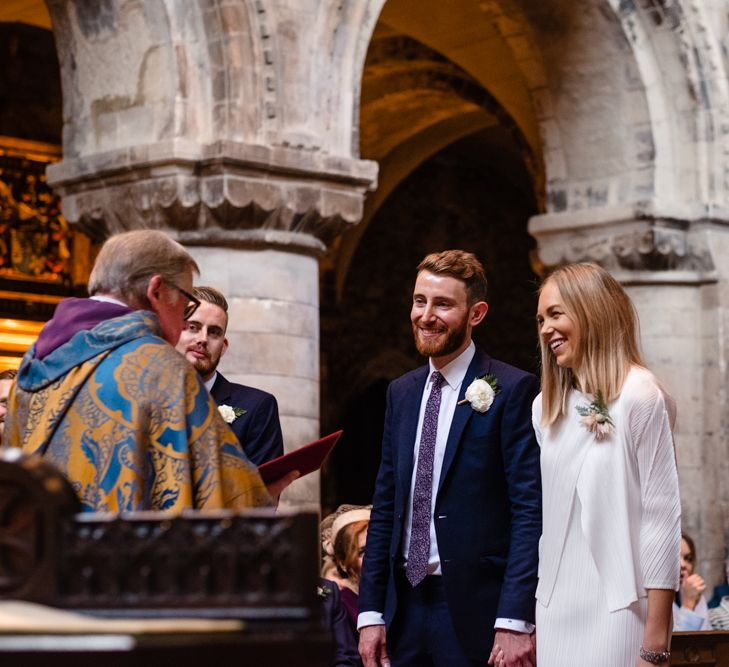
[{"x1": 359, "y1": 348, "x2": 542, "y2": 664}]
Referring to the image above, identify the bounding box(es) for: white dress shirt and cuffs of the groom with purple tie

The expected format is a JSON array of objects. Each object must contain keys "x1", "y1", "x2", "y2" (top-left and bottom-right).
[{"x1": 357, "y1": 341, "x2": 534, "y2": 632}]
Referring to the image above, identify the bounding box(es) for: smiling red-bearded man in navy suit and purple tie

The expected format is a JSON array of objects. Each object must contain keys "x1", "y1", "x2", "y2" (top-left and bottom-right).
[{"x1": 358, "y1": 250, "x2": 541, "y2": 667}]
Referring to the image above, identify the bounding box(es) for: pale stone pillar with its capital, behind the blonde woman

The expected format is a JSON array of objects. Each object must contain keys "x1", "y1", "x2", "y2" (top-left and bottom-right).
[{"x1": 530, "y1": 204, "x2": 729, "y2": 585}]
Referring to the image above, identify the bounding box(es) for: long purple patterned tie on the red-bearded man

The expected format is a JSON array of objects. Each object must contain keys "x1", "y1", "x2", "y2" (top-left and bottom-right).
[{"x1": 405, "y1": 371, "x2": 445, "y2": 586}]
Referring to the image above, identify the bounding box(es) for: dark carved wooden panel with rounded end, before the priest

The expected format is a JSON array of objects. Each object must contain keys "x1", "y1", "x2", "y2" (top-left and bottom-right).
[{"x1": 0, "y1": 450, "x2": 319, "y2": 620}]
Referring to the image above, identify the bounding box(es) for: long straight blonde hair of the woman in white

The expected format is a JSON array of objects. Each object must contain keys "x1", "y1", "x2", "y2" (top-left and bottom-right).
[{"x1": 539, "y1": 262, "x2": 645, "y2": 426}]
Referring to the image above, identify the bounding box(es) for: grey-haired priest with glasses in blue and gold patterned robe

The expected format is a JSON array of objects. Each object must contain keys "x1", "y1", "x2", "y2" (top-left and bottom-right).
[{"x1": 6, "y1": 230, "x2": 278, "y2": 513}]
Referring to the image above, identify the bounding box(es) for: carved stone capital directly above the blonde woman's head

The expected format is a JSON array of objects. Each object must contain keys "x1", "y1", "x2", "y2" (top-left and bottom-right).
[{"x1": 529, "y1": 197, "x2": 729, "y2": 284}]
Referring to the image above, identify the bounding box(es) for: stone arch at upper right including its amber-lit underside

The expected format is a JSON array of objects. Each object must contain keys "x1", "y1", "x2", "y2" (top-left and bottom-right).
[{"x1": 350, "y1": 0, "x2": 728, "y2": 219}]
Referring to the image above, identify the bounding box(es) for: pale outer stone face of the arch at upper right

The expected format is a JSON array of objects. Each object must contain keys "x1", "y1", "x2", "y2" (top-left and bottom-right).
[{"x1": 609, "y1": 0, "x2": 729, "y2": 203}]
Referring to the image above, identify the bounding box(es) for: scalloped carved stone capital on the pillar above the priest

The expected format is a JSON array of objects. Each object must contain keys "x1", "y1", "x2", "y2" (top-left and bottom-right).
[{"x1": 48, "y1": 141, "x2": 377, "y2": 252}]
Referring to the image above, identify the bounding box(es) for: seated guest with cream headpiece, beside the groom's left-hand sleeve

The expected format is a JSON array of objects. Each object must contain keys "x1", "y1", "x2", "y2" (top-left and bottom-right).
[{"x1": 322, "y1": 505, "x2": 370, "y2": 631}]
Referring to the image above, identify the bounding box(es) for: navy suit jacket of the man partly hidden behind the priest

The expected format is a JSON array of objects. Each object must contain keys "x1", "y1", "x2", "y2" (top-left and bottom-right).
[{"x1": 210, "y1": 373, "x2": 283, "y2": 466}]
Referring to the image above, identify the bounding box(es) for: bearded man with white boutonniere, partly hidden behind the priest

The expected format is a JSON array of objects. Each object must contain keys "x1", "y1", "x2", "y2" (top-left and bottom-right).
[{"x1": 177, "y1": 287, "x2": 283, "y2": 465}]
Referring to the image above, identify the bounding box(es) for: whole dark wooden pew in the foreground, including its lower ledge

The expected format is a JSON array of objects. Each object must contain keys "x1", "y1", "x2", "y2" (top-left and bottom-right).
[{"x1": 0, "y1": 450, "x2": 331, "y2": 667}]
